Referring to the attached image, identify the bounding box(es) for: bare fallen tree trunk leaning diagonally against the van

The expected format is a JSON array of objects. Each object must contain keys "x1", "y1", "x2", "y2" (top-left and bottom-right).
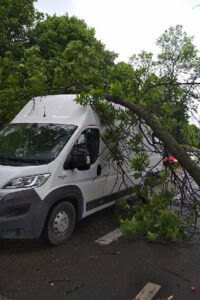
[{"x1": 105, "y1": 95, "x2": 200, "y2": 187}]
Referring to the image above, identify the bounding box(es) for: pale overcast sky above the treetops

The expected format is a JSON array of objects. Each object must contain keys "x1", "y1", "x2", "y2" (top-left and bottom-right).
[{"x1": 35, "y1": 0, "x2": 200, "y2": 61}]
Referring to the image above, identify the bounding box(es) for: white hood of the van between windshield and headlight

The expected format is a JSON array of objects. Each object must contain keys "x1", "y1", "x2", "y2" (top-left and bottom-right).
[{"x1": 0, "y1": 165, "x2": 49, "y2": 189}]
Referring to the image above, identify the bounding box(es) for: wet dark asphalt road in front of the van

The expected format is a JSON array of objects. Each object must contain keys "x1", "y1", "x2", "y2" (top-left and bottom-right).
[{"x1": 0, "y1": 208, "x2": 200, "y2": 300}]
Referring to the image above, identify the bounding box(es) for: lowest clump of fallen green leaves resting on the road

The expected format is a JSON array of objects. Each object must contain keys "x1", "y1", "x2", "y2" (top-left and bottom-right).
[{"x1": 120, "y1": 174, "x2": 187, "y2": 242}]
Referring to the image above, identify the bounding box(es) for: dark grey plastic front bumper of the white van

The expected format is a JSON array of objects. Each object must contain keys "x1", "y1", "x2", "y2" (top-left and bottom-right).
[{"x1": 0, "y1": 189, "x2": 49, "y2": 239}]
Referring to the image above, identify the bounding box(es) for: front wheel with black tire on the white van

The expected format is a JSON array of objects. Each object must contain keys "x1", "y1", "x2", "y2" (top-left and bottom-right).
[{"x1": 45, "y1": 201, "x2": 76, "y2": 246}]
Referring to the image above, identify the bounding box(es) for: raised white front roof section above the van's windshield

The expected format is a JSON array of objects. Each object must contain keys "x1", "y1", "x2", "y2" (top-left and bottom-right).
[{"x1": 12, "y1": 95, "x2": 100, "y2": 126}]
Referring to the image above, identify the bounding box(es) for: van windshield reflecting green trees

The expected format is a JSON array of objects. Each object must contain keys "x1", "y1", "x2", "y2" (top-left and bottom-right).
[{"x1": 0, "y1": 123, "x2": 77, "y2": 165}]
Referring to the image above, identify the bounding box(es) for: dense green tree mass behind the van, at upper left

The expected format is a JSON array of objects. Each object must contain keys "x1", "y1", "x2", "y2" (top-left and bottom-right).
[{"x1": 0, "y1": 0, "x2": 116, "y2": 127}]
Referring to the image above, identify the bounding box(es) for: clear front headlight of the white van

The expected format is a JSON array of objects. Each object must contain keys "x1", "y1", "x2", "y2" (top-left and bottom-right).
[{"x1": 4, "y1": 174, "x2": 50, "y2": 189}]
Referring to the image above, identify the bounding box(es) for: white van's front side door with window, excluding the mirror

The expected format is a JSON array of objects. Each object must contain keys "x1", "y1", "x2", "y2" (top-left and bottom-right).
[{"x1": 65, "y1": 128, "x2": 105, "y2": 214}]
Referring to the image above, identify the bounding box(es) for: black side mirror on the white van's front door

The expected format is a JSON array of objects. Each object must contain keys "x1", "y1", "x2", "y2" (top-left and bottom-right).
[{"x1": 64, "y1": 147, "x2": 91, "y2": 171}]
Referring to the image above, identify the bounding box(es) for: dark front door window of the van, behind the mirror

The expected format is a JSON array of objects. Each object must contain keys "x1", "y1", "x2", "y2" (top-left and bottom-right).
[{"x1": 74, "y1": 128, "x2": 100, "y2": 164}]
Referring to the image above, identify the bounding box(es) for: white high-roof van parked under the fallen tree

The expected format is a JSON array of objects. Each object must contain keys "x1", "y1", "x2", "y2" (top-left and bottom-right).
[{"x1": 0, "y1": 95, "x2": 161, "y2": 245}]
